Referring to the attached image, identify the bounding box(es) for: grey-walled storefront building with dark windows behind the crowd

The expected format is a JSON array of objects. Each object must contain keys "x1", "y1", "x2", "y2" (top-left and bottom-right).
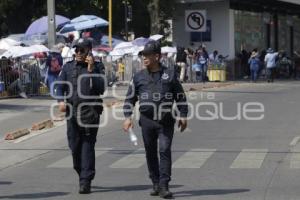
[{"x1": 173, "y1": 0, "x2": 300, "y2": 59}]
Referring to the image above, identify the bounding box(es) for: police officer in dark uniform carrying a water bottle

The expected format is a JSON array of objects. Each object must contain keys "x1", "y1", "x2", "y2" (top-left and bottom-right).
[{"x1": 123, "y1": 41, "x2": 188, "y2": 198}]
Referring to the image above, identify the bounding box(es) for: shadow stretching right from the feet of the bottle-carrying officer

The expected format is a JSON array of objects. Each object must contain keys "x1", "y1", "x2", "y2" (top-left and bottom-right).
[{"x1": 173, "y1": 189, "x2": 250, "y2": 197}]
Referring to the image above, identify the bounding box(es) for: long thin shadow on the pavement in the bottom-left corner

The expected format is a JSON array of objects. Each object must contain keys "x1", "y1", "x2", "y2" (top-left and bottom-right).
[{"x1": 0, "y1": 192, "x2": 69, "y2": 199}]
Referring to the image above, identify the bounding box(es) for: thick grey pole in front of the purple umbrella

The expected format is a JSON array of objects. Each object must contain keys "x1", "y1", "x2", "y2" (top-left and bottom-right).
[{"x1": 47, "y1": 0, "x2": 56, "y2": 48}]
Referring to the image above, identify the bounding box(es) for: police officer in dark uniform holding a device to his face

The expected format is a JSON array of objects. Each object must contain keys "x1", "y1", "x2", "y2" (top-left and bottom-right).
[{"x1": 57, "y1": 38, "x2": 104, "y2": 194}]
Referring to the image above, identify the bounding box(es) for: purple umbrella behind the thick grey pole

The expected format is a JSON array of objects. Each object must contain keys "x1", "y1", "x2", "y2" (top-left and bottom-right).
[{"x1": 25, "y1": 15, "x2": 70, "y2": 36}]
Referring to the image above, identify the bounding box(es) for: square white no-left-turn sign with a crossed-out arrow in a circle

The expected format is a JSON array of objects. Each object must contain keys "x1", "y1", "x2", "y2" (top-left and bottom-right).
[{"x1": 185, "y1": 10, "x2": 206, "y2": 32}]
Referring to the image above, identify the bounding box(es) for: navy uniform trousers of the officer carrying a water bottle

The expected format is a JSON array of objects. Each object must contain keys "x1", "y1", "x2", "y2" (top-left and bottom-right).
[{"x1": 140, "y1": 115, "x2": 174, "y2": 186}]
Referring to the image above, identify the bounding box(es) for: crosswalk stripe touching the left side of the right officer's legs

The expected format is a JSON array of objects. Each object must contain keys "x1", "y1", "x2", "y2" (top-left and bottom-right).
[{"x1": 110, "y1": 149, "x2": 146, "y2": 169}]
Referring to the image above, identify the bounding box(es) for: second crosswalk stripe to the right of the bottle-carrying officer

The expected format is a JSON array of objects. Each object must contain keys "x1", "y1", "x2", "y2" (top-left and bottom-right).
[{"x1": 230, "y1": 149, "x2": 268, "y2": 169}]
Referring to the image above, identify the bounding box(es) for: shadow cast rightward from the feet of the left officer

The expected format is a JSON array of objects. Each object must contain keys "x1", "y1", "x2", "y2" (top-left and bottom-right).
[{"x1": 92, "y1": 185, "x2": 183, "y2": 193}]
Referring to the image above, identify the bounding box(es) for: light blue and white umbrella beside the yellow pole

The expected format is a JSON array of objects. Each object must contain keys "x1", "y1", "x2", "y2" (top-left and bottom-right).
[{"x1": 60, "y1": 15, "x2": 108, "y2": 33}]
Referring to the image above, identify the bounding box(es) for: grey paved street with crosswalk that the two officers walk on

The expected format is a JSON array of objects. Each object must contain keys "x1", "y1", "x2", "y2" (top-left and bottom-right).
[{"x1": 0, "y1": 82, "x2": 300, "y2": 200}]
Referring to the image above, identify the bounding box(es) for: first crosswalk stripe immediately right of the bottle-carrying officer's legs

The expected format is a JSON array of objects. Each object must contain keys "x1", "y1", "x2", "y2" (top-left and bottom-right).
[{"x1": 173, "y1": 149, "x2": 216, "y2": 169}]
